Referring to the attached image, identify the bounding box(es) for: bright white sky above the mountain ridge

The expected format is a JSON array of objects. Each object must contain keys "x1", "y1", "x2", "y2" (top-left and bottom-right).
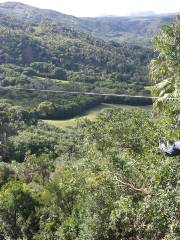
[{"x1": 0, "y1": 0, "x2": 180, "y2": 17}]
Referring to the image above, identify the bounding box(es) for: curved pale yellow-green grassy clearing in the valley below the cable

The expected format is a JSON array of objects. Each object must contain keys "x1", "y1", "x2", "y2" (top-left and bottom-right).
[{"x1": 44, "y1": 103, "x2": 150, "y2": 127}]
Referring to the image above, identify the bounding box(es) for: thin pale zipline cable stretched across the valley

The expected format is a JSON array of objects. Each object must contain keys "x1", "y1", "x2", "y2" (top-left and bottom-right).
[{"x1": 0, "y1": 86, "x2": 180, "y2": 100}]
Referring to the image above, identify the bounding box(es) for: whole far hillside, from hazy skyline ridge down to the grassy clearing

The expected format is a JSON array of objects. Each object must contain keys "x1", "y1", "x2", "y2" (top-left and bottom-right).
[{"x1": 0, "y1": 2, "x2": 176, "y2": 119}]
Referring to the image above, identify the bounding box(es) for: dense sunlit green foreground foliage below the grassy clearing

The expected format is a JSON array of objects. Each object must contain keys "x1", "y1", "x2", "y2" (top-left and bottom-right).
[{"x1": 0, "y1": 104, "x2": 180, "y2": 240}]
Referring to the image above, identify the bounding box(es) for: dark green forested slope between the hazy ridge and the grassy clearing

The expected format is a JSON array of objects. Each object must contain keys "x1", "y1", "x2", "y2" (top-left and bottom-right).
[{"x1": 0, "y1": 22, "x2": 152, "y2": 119}]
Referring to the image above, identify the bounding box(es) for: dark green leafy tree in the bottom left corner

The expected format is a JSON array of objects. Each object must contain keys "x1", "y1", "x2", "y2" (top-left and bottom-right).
[{"x1": 0, "y1": 182, "x2": 38, "y2": 240}]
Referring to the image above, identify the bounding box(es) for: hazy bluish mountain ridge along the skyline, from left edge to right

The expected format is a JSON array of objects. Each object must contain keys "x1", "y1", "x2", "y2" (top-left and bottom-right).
[{"x1": 0, "y1": 2, "x2": 176, "y2": 42}]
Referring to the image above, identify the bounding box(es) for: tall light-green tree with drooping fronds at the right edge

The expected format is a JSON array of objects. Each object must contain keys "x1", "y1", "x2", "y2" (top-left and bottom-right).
[{"x1": 150, "y1": 17, "x2": 180, "y2": 113}]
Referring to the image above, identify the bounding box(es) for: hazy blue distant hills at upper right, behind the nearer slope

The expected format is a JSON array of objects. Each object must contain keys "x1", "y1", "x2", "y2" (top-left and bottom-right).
[{"x1": 83, "y1": 14, "x2": 177, "y2": 44}]
